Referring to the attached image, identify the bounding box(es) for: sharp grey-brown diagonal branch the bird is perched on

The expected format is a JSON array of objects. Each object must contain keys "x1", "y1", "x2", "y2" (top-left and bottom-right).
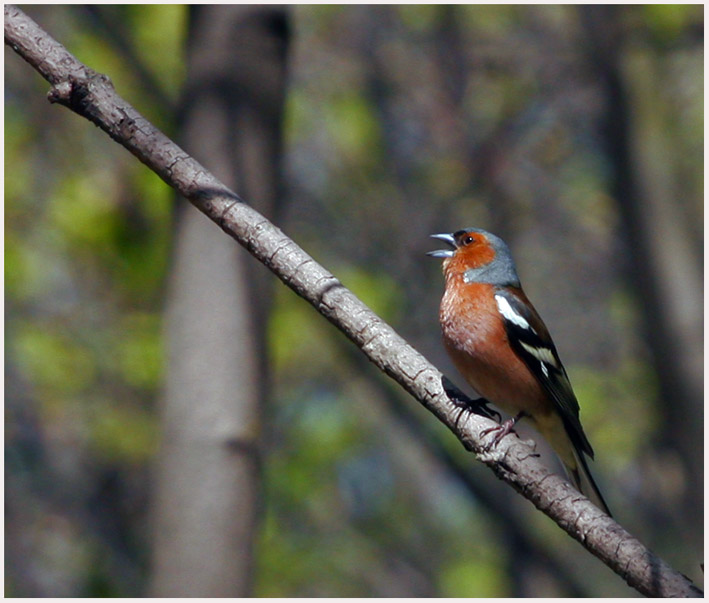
[{"x1": 5, "y1": 5, "x2": 702, "y2": 597}]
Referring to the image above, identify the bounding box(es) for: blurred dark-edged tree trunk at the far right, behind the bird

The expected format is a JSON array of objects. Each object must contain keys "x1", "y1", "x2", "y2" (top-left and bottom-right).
[{"x1": 582, "y1": 6, "x2": 704, "y2": 549}]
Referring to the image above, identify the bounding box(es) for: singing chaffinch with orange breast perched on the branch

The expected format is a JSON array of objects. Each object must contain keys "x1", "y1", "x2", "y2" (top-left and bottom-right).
[{"x1": 428, "y1": 228, "x2": 610, "y2": 515}]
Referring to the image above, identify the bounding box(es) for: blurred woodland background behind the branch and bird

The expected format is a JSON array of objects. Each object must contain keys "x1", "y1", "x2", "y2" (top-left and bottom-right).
[{"x1": 5, "y1": 5, "x2": 704, "y2": 597}]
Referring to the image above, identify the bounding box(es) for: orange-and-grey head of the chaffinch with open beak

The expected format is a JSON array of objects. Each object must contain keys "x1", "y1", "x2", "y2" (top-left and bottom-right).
[{"x1": 426, "y1": 228, "x2": 519, "y2": 287}]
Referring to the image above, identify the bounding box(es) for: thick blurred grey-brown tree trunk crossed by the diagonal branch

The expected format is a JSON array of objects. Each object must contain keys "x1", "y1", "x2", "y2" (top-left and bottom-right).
[{"x1": 150, "y1": 5, "x2": 288, "y2": 597}]
